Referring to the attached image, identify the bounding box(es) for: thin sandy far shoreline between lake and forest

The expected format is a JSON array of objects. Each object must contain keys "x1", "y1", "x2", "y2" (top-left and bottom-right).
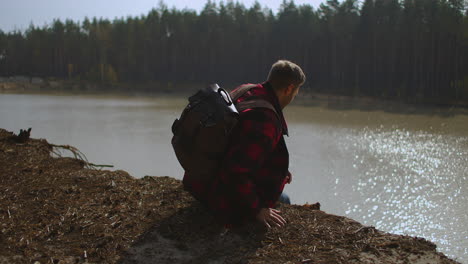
[{"x1": 0, "y1": 76, "x2": 468, "y2": 110}]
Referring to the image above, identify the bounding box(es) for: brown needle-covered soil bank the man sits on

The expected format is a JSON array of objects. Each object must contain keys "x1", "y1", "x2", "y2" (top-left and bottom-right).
[{"x1": 0, "y1": 129, "x2": 457, "y2": 263}]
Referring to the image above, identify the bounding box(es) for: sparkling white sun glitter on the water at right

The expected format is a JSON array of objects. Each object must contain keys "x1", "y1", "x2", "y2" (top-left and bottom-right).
[{"x1": 336, "y1": 127, "x2": 468, "y2": 256}]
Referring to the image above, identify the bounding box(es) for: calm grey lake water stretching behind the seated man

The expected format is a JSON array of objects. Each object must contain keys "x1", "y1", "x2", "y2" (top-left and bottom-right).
[{"x1": 0, "y1": 93, "x2": 468, "y2": 263}]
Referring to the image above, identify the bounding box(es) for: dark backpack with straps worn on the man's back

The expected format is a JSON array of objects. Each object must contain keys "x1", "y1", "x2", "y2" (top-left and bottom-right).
[{"x1": 171, "y1": 84, "x2": 276, "y2": 180}]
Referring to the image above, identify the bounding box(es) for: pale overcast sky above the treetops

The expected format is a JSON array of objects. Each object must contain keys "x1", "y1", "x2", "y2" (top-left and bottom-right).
[{"x1": 0, "y1": 0, "x2": 325, "y2": 32}]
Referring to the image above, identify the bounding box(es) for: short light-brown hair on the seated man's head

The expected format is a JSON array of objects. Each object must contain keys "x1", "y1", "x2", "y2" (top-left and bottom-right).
[{"x1": 267, "y1": 60, "x2": 306, "y2": 89}]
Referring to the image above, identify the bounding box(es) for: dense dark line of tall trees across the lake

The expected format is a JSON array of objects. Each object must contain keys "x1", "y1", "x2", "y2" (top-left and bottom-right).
[{"x1": 0, "y1": 0, "x2": 468, "y2": 101}]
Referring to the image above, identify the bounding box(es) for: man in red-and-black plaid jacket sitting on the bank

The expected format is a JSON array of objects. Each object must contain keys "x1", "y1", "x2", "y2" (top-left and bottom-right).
[{"x1": 183, "y1": 60, "x2": 305, "y2": 227}]
